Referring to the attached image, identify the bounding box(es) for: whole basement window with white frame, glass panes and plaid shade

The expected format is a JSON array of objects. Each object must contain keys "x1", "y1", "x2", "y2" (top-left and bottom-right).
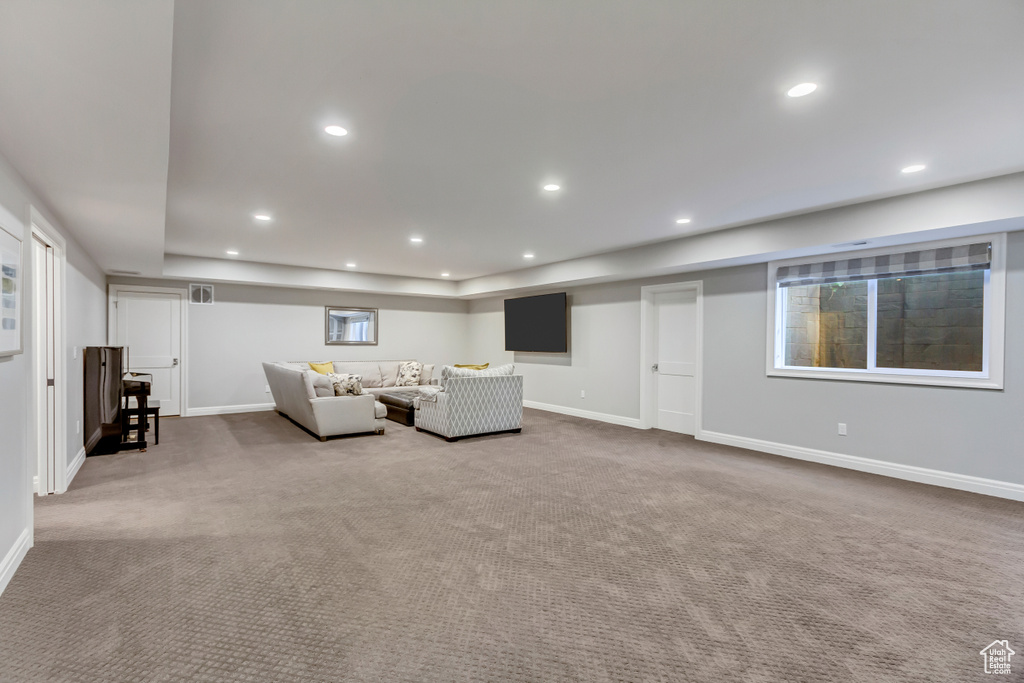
[{"x1": 768, "y1": 233, "x2": 1006, "y2": 389}]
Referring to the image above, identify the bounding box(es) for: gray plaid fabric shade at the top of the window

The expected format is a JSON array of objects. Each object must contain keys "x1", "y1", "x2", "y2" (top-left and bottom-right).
[{"x1": 775, "y1": 242, "x2": 992, "y2": 287}]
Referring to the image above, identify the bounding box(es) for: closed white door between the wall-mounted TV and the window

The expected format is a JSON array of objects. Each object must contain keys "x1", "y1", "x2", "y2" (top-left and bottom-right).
[{"x1": 651, "y1": 290, "x2": 697, "y2": 434}]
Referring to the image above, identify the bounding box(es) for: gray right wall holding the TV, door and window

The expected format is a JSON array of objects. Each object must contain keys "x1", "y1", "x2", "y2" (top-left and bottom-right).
[{"x1": 469, "y1": 231, "x2": 1024, "y2": 483}]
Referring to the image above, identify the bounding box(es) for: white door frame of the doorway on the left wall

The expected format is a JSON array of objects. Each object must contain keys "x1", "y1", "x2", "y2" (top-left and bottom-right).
[{"x1": 26, "y1": 206, "x2": 70, "y2": 496}]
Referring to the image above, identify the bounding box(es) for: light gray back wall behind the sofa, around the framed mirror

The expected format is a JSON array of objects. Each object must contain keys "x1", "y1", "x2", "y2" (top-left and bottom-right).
[{"x1": 111, "y1": 278, "x2": 469, "y2": 410}]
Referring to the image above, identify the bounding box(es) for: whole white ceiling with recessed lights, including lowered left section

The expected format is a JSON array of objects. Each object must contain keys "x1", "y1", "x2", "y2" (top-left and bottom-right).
[{"x1": 0, "y1": 0, "x2": 1024, "y2": 280}]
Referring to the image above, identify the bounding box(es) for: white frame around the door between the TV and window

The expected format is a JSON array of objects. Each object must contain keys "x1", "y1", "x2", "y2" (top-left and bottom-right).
[{"x1": 640, "y1": 280, "x2": 703, "y2": 439}]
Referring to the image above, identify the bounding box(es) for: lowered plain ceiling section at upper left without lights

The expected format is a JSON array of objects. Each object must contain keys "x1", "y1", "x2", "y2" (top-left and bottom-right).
[{"x1": 0, "y1": 0, "x2": 174, "y2": 273}]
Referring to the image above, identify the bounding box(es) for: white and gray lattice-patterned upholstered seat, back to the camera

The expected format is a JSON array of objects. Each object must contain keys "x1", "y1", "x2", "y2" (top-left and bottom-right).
[{"x1": 416, "y1": 366, "x2": 522, "y2": 441}]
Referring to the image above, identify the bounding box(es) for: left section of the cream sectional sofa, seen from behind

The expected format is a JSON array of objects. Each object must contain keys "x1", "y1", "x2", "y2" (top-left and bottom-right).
[{"x1": 263, "y1": 362, "x2": 387, "y2": 441}]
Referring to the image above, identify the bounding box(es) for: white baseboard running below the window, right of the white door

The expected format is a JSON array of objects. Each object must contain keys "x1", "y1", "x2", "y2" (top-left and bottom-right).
[{"x1": 697, "y1": 431, "x2": 1024, "y2": 501}]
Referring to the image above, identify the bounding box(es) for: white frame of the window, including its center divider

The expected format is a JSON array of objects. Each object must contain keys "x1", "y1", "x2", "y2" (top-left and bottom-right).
[{"x1": 765, "y1": 232, "x2": 1007, "y2": 389}]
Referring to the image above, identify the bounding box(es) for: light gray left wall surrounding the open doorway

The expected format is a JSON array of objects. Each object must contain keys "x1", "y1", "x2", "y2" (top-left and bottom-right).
[{"x1": 0, "y1": 150, "x2": 106, "y2": 591}]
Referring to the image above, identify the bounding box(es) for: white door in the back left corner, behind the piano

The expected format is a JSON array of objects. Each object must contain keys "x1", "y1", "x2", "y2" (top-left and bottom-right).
[{"x1": 114, "y1": 290, "x2": 182, "y2": 417}]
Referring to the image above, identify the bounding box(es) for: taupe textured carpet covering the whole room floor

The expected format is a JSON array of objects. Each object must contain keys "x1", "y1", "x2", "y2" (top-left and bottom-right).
[{"x1": 0, "y1": 411, "x2": 1024, "y2": 683}]
